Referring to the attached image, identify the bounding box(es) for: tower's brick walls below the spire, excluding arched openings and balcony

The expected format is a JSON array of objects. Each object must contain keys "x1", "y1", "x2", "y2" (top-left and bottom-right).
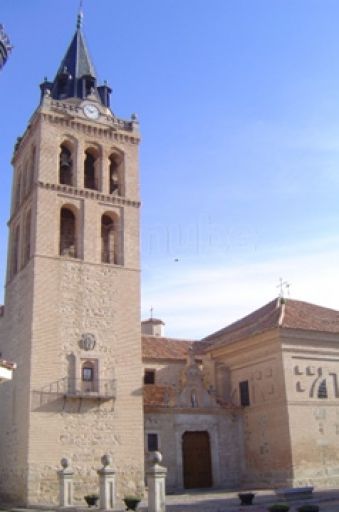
[{"x1": 0, "y1": 100, "x2": 144, "y2": 505}]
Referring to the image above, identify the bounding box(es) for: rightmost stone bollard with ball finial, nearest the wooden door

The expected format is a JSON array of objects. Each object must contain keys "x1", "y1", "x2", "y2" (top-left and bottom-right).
[{"x1": 146, "y1": 452, "x2": 167, "y2": 512}]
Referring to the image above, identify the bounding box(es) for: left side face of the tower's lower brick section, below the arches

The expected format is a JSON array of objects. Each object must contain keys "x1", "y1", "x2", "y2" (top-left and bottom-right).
[{"x1": 0, "y1": 261, "x2": 33, "y2": 503}]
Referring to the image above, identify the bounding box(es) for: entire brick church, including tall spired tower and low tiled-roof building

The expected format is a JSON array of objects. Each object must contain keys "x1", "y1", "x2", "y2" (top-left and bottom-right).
[{"x1": 0, "y1": 12, "x2": 339, "y2": 505}]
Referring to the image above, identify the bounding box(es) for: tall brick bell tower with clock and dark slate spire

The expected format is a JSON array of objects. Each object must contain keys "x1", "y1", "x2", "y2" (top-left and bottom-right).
[{"x1": 0, "y1": 14, "x2": 144, "y2": 505}]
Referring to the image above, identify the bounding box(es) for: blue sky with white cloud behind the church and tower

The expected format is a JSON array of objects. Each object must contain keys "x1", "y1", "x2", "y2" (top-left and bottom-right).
[{"x1": 0, "y1": 0, "x2": 339, "y2": 338}]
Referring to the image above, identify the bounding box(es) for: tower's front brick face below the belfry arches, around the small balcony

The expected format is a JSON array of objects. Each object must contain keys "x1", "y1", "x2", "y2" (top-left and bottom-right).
[{"x1": 29, "y1": 258, "x2": 143, "y2": 503}]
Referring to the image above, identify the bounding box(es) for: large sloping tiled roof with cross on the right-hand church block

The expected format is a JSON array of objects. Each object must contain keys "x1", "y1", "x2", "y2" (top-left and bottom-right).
[{"x1": 202, "y1": 299, "x2": 339, "y2": 349}]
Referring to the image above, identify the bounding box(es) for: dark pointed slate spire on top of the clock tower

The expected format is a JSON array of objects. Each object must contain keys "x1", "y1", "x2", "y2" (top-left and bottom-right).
[{"x1": 40, "y1": 12, "x2": 111, "y2": 107}]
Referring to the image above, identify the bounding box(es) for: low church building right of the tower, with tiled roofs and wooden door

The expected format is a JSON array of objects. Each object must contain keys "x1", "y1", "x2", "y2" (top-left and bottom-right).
[{"x1": 142, "y1": 298, "x2": 339, "y2": 489}]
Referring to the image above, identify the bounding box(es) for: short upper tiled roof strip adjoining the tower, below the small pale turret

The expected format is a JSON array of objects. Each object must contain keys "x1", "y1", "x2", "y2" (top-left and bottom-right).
[{"x1": 142, "y1": 335, "x2": 194, "y2": 360}]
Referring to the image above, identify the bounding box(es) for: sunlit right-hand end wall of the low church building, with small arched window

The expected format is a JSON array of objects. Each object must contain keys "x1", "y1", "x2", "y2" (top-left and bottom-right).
[{"x1": 283, "y1": 333, "x2": 339, "y2": 488}]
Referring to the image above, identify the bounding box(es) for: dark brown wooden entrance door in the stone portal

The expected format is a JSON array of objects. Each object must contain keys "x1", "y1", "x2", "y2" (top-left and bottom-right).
[{"x1": 182, "y1": 431, "x2": 212, "y2": 489}]
